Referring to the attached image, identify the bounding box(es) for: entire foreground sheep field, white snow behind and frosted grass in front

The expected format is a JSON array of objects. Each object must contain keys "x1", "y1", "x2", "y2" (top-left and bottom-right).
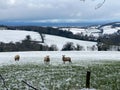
[{"x1": 0, "y1": 51, "x2": 120, "y2": 90}]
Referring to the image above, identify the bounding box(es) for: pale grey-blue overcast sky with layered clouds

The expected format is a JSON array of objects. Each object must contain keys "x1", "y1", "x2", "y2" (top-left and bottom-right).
[{"x1": 0, "y1": 0, "x2": 120, "y2": 22}]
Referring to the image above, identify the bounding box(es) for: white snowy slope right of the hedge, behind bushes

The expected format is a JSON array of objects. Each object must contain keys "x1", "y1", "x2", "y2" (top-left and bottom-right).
[{"x1": 45, "y1": 35, "x2": 97, "y2": 51}]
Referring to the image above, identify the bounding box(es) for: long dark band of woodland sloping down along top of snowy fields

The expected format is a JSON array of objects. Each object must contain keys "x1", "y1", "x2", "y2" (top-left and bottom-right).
[{"x1": 6, "y1": 26, "x2": 97, "y2": 42}]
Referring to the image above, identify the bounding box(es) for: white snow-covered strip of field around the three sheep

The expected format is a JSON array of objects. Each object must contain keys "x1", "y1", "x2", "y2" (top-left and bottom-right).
[{"x1": 0, "y1": 51, "x2": 120, "y2": 66}]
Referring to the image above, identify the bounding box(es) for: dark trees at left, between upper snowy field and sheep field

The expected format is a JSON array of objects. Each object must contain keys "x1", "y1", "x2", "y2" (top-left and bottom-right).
[{"x1": 0, "y1": 35, "x2": 57, "y2": 52}]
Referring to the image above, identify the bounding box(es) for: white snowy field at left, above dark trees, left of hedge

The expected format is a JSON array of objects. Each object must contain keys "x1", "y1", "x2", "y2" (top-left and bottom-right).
[{"x1": 0, "y1": 30, "x2": 41, "y2": 43}]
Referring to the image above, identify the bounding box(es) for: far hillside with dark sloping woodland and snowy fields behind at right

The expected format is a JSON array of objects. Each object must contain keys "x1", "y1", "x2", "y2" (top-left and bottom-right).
[{"x1": 1, "y1": 22, "x2": 120, "y2": 41}]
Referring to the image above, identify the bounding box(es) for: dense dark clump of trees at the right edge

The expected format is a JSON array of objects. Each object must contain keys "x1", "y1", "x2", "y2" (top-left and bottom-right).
[{"x1": 97, "y1": 30, "x2": 120, "y2": 51}]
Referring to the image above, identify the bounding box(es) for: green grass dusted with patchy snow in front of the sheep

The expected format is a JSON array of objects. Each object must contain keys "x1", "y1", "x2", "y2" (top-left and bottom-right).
[{"x1": 0, "y1": 60, "x2": 120, "y2": 90}]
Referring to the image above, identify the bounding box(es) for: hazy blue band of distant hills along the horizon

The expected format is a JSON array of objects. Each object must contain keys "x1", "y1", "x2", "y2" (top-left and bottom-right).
[{"x1": 0, "y1": 21, "x2": 106, "y2": 27}]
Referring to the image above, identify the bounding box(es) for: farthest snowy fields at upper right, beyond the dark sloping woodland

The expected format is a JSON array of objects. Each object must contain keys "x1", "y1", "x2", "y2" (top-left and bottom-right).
[{"x1": 60, "y1": 23, "x2": 120, "y2": 37}]
